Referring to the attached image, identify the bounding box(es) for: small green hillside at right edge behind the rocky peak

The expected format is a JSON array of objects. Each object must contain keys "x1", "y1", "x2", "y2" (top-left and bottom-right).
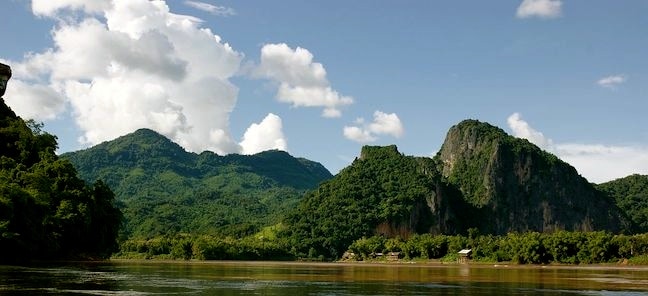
[{"x1": 596, "y1": 174, "x2": 648, "y2": 233}]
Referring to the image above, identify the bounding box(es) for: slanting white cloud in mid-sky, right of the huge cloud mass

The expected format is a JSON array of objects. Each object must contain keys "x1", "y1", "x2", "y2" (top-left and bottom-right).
[{"x1": 254, "y1": 43, "x2": 353, "y2": 117}]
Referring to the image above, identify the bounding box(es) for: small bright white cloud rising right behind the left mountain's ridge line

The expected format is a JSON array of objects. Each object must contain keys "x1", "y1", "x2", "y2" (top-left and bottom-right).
[{"x1": 241, "y1": 113, "x2": 288, "y2": 154}]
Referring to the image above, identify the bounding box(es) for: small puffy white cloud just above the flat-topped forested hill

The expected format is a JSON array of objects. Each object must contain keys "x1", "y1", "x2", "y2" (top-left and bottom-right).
[{"x1": 343, "y1": 111, "x2": 405, "y2": 143}]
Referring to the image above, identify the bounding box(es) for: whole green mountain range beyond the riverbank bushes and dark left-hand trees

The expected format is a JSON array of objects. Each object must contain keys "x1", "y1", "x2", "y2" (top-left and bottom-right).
[{"x1": 62, "y1": 120, "x2": 648, "y2": 258}]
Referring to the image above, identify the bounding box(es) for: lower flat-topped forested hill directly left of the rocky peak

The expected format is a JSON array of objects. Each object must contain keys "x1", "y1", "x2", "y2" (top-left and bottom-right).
[{"x1": 284, "y1": 146, "x2": 438, "y2": 258}]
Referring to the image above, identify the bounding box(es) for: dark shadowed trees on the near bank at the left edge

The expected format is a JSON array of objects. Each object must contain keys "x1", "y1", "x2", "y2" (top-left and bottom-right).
[{"x1": 0, "y1": 101, "x2": 121, "y2": 262}]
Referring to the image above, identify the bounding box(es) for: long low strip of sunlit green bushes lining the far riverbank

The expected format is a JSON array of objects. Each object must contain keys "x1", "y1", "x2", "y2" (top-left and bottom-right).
[{"x1": 114, "y1": 230, "x2": 648, "y2": 265}]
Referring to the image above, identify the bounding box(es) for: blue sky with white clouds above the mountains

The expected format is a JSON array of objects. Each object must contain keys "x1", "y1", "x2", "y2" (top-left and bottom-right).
[{"x1": 0, "y1": 0, "x2": 648, "y2": 182}]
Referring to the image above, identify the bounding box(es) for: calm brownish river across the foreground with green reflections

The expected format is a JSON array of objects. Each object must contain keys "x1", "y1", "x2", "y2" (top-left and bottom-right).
[{"x1": 0, "y1": 261, "x2": 648, "y2": 296}]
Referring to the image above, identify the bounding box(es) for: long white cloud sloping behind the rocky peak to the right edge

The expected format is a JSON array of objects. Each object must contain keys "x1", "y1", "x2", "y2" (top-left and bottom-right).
[{"x1": 508, "y1": 113, "x2": 648, "y2": 183}]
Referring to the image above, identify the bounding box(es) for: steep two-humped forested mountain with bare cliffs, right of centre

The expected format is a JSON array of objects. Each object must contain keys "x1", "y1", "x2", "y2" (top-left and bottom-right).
[{"x1": 287, "y1": 120, "x2": 631, "y2": 258}]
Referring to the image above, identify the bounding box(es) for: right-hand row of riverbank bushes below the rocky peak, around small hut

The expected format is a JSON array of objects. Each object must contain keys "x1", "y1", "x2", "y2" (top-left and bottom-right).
[{"x1": 348, "y1": 231, "x2": 648, "y2": 264}]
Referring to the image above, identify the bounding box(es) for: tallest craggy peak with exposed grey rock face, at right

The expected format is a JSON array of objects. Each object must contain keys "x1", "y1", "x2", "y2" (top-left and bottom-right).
[{"x1": 437, "y1": 120, "x2": 628, "y2": 234}]
